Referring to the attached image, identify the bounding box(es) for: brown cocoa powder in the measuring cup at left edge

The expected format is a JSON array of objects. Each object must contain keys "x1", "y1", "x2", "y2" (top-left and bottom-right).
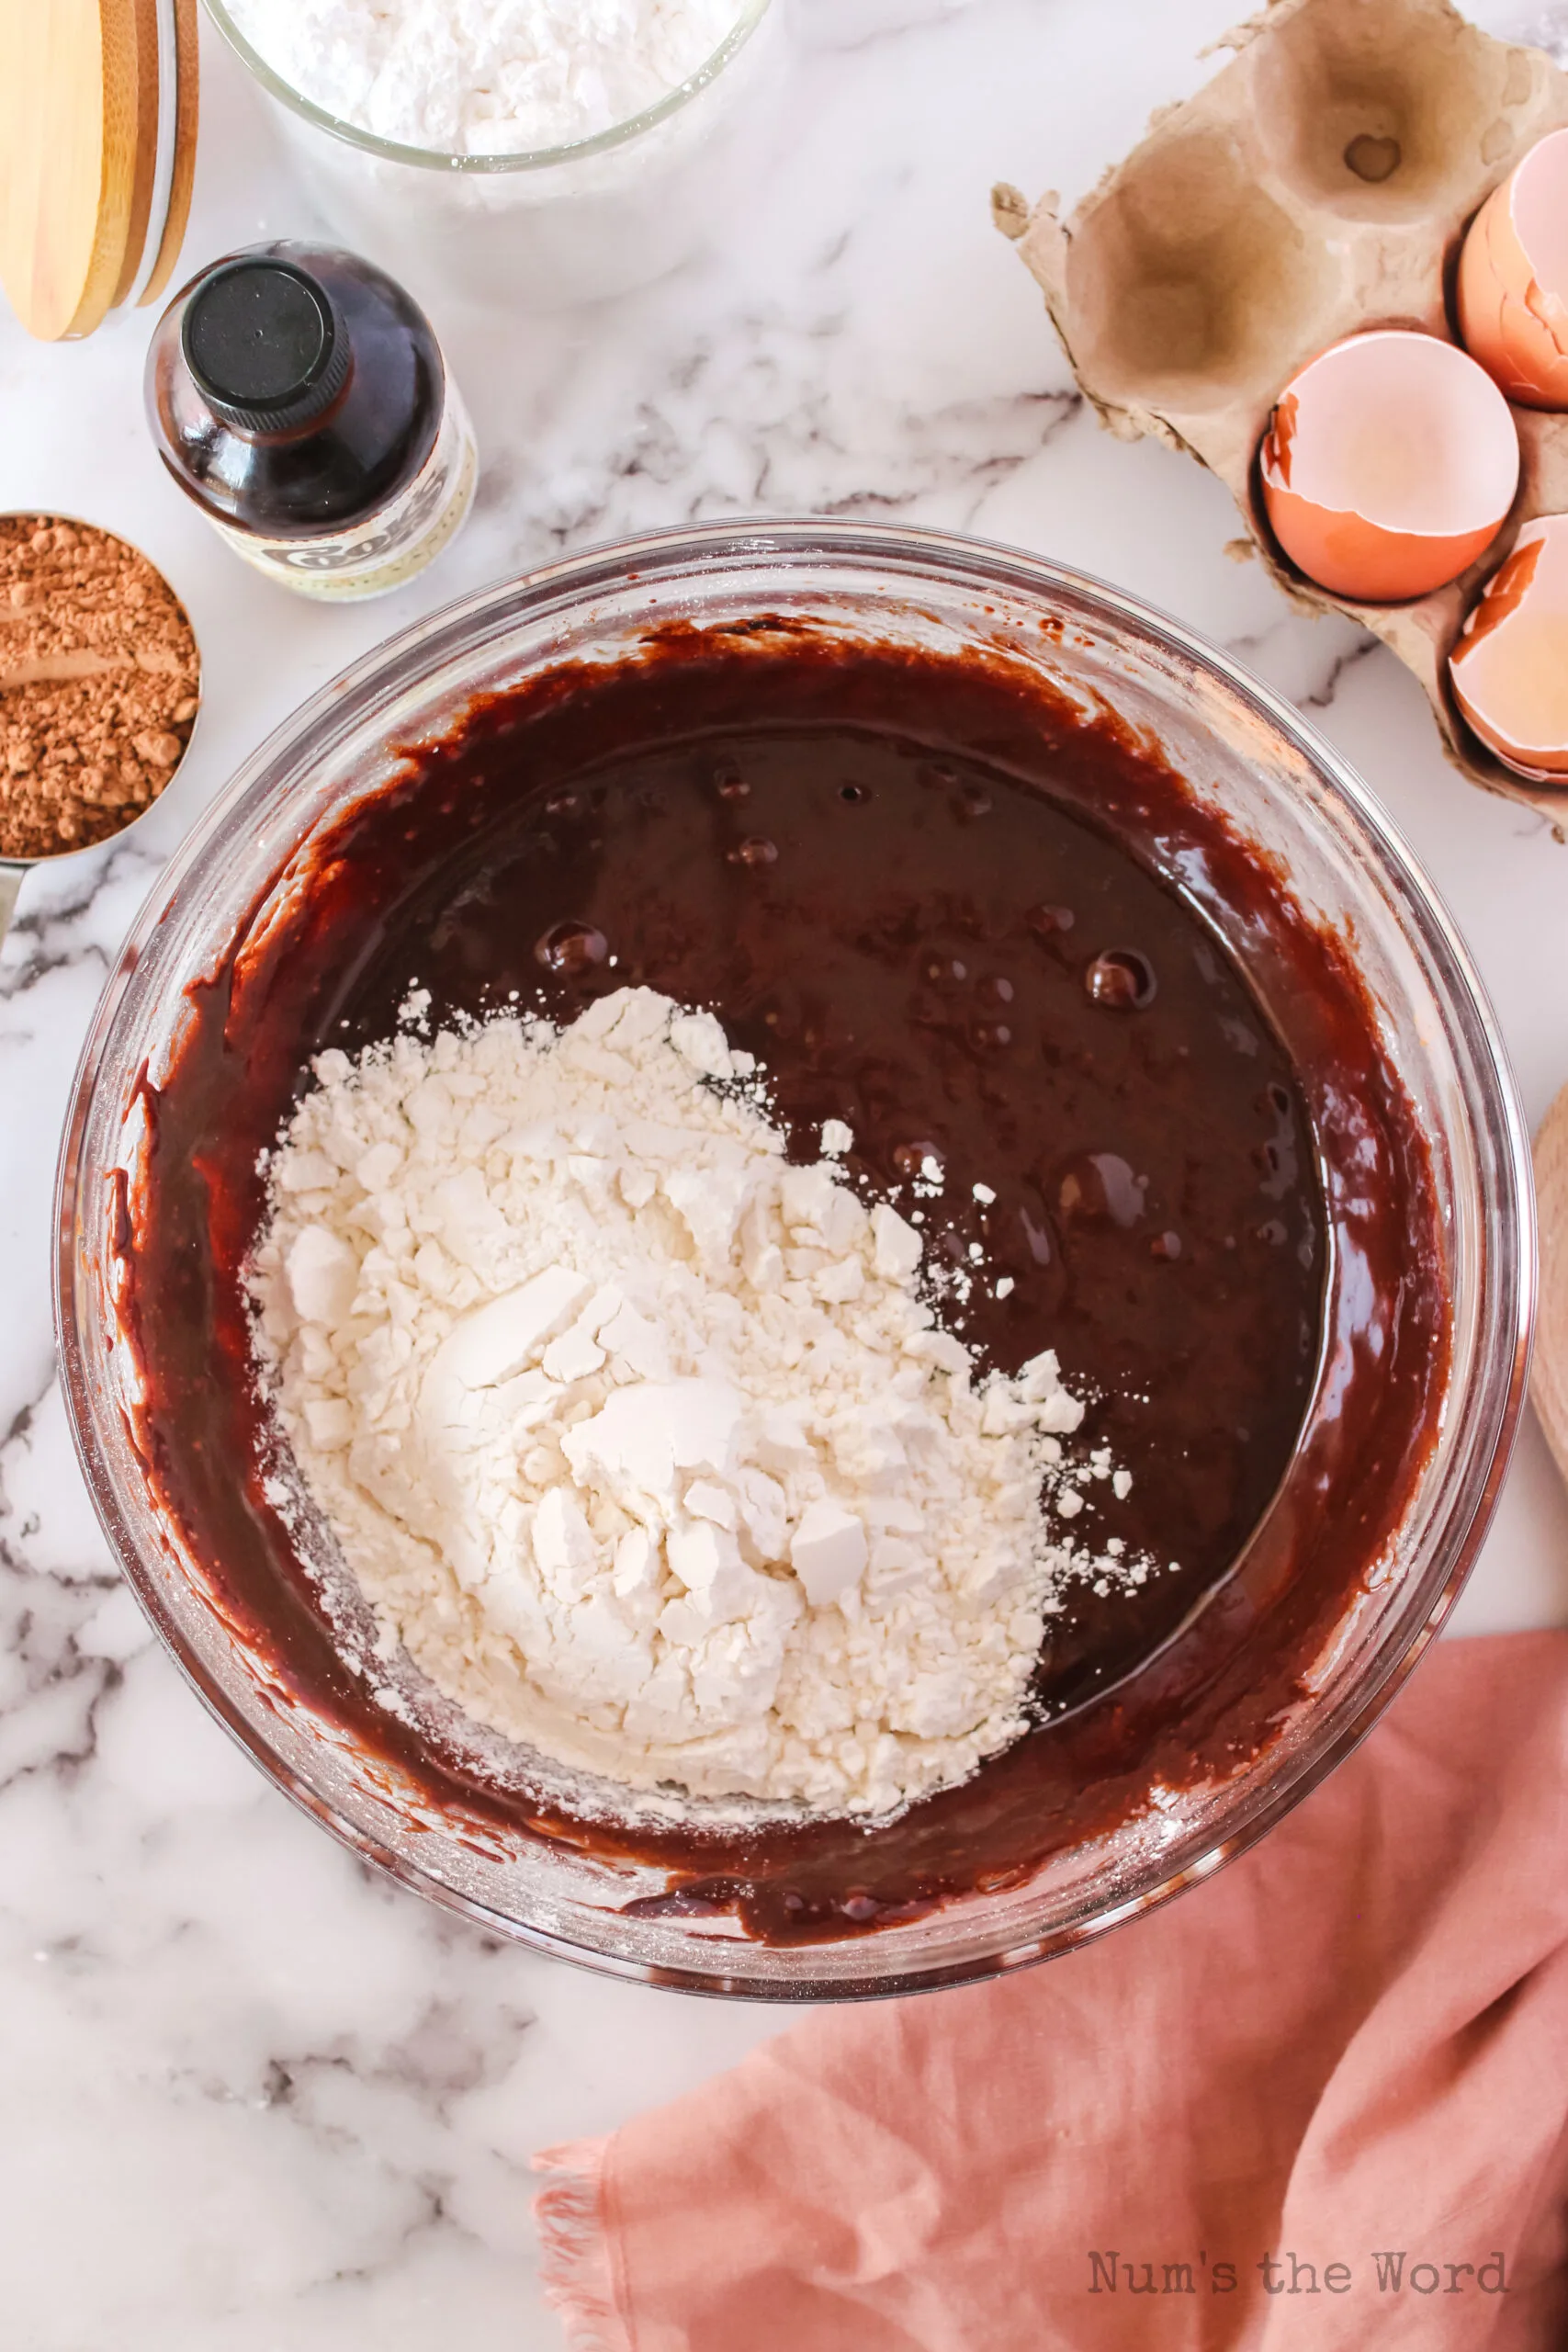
[{"x1": 0, "y1": 515, "x2": 200, "y2": 858}]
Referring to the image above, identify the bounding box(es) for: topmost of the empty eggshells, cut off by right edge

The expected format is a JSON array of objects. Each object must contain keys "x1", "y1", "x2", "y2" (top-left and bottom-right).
[{"x1": 1458, "y1": 131, "x2": 1568, "y2": 409}]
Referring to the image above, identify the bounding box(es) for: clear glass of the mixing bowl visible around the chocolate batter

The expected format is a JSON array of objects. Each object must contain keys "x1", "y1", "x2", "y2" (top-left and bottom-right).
[{"x1": 56, "y1": 522, "x2": 1535, "y2": 1999}]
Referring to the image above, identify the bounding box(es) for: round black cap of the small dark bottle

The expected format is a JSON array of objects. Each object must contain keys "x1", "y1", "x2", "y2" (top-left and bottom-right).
[{"x1": 181, "y1": 254, "x2": 353, "y2": 433}]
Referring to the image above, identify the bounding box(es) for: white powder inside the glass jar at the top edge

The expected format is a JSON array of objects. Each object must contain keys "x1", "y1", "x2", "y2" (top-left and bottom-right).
[{"x1": 228, "y1": 0, "x2": 740, "y2": 155}]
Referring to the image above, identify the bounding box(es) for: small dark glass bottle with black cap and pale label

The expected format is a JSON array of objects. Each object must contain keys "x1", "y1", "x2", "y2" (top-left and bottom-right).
[{"x1": 146, "y1": 240, "x2": 478, "y2": 600}]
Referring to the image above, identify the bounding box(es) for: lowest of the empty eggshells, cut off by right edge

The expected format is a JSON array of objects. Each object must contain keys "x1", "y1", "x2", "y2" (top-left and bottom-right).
[{"x1": 1448, "y1": 515, "x2": 1568, "y2": 783}]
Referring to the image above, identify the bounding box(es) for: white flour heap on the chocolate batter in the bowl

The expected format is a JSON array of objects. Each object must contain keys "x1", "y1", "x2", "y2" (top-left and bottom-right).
[{"x1": 252, "y1": 988, "x2": 1145, "y2": 1814}]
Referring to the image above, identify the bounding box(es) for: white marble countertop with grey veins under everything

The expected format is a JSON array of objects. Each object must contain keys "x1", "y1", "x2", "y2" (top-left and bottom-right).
[{"x1": 0, "y1": 0, "x2": 1568, "y2": 2352}]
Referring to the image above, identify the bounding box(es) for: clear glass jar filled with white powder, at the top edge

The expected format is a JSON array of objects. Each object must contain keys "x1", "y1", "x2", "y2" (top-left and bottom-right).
[{"x1": 205, "y1": 0, "x2": 787, "y2": 311}]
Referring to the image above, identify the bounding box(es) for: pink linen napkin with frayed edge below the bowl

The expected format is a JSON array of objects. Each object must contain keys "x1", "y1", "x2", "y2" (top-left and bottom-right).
[{"x1": 536, "y1": 1633, "x2": 1568, "y2": 2352}]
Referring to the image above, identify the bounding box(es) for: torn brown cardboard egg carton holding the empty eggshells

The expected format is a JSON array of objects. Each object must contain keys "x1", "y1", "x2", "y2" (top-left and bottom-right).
[{"x1": 995, "y1": 0, "x2": 1568, "y2": 828}]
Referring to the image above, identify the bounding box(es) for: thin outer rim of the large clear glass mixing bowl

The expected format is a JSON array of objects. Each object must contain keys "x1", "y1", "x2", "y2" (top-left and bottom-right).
[{"x1": 54, "y1": 517, "x2": 1538, "y2": 2002}]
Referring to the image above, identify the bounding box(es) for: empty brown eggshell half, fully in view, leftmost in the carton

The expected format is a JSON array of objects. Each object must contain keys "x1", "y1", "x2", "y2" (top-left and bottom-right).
[{"x1": 1260, "y1": 327, "x2": 1518, "y2": 605}]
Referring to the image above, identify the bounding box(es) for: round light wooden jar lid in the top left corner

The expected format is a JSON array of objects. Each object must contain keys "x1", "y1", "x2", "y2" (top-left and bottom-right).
[{"x1": 0, "y1": 0, "x2": 197, "y2": 341}]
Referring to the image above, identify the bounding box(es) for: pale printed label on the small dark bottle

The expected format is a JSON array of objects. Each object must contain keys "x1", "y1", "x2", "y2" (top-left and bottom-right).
[{"x1": 209, "y1": 381, "x2": 479, "y2": 602}]
